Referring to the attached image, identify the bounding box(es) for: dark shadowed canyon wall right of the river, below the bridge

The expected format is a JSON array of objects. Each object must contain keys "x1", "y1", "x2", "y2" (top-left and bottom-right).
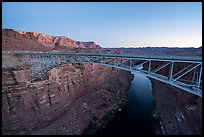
[{"x1": 152, "y1": 80, "x2": 202, "y2": 135}]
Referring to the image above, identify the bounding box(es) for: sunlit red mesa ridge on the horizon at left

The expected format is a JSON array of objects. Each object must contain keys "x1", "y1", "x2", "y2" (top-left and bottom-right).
[{"x1": 2, "y1": 29, "x2": 101, "y2": 51}]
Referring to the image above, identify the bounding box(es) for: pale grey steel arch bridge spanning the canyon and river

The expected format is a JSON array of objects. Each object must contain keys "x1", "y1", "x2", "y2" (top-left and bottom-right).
[{"x1": 16, "y1": 51, "x2": 202, "y2": 97}]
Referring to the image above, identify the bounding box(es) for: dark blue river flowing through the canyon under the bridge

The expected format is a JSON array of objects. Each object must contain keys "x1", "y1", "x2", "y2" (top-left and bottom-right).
[{"x1": 99, "y1": 72, "x2": 160, "y2": 135}]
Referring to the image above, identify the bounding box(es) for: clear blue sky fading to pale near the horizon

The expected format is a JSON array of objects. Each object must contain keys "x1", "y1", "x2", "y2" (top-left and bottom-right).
[{"x1": 2, "y1": 2, "x2": 202, "y2": 48}]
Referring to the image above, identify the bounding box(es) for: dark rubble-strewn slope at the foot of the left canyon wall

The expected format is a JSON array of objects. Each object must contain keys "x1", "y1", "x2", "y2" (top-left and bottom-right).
[{"x1": 31, "y1": 90, "x2": 127, "y2": 135}]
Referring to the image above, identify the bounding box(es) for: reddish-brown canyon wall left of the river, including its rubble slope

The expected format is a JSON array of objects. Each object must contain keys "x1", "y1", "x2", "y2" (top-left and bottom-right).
[{"x1": 2, "y1": 61, "x2": 132, "y2": 134}]
